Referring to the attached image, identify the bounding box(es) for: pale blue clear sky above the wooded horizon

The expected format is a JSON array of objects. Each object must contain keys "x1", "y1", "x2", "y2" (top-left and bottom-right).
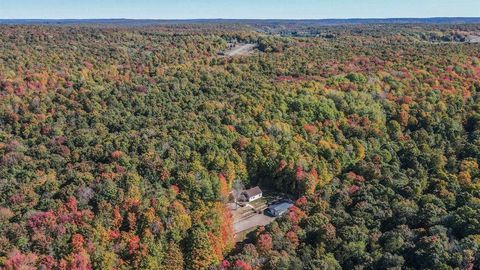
[{"x1": 0, "y1": 0, "x2": 480, "y2": 19}]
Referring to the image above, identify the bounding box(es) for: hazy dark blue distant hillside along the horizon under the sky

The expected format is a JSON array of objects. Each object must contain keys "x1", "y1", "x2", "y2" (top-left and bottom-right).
[{"x1": 0, "y1": 17, "x2": 480, "y2": 26}]
